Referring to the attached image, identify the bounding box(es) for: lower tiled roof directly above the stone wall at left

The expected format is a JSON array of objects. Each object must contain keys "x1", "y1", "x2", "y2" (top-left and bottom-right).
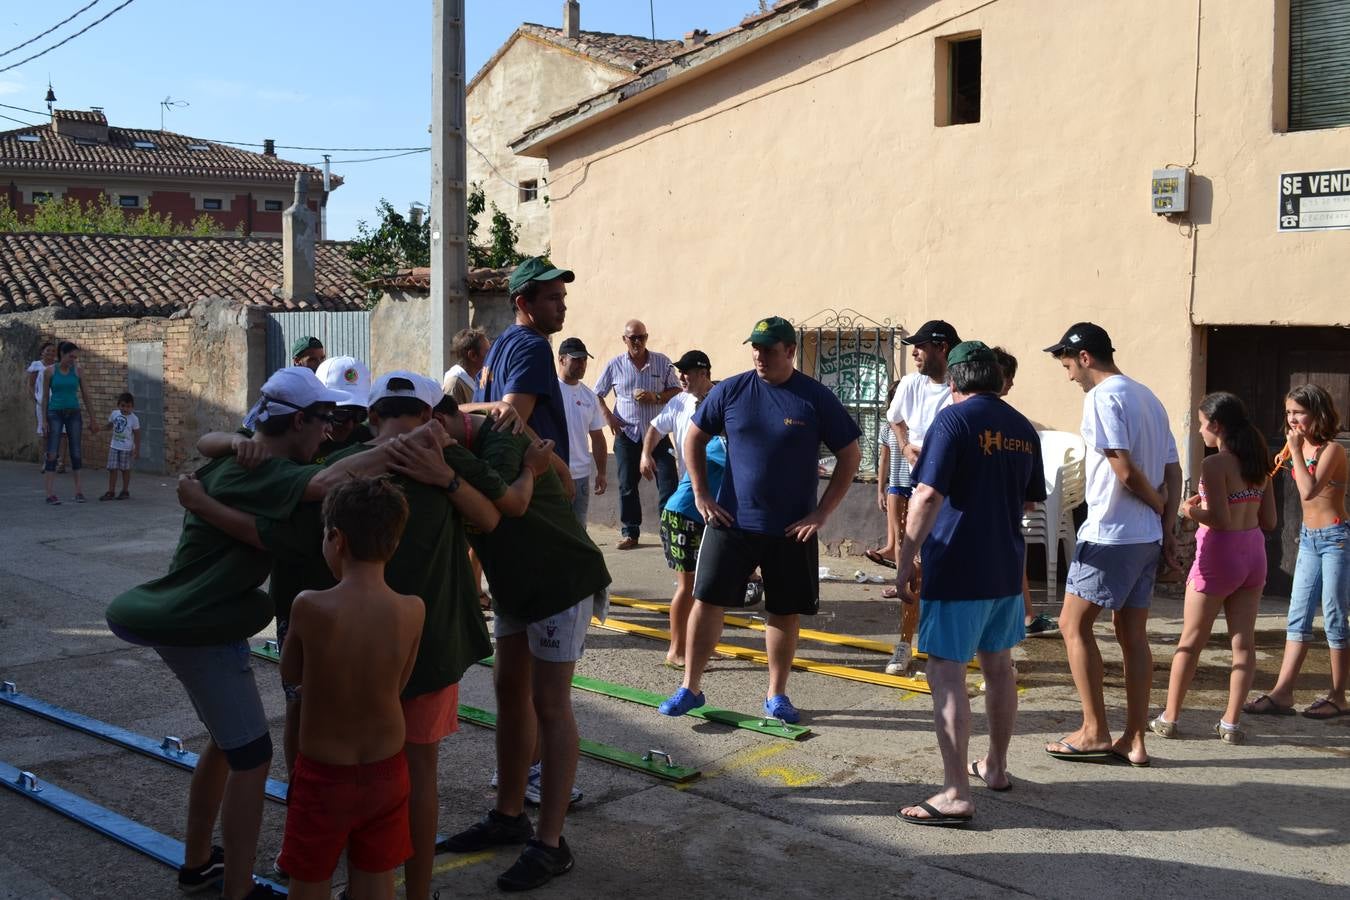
[{"x1": 0, "y1": 232, "x2": 366, "y2": 318}]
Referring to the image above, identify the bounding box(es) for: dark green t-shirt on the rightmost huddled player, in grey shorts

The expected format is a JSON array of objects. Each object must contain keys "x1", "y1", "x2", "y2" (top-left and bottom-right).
[{"x1": 461, "y1": 424, "x2": 612, "y2": 622}]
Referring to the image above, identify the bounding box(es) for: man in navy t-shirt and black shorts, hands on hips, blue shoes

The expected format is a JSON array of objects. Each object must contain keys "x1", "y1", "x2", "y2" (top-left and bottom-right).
[{"x1": 660, "y1": 316, "x2": 861, "y2": 722}]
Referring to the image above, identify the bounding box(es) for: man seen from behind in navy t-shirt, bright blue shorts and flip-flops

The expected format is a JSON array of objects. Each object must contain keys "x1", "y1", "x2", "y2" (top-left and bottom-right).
[{"x1": 896, "y1": 340, "x2": 1045, "y2": 824}]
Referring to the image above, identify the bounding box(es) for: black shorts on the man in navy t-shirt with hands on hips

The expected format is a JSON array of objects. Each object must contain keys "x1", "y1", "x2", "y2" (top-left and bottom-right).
[{"x1": 694, "y1": 528, "x2": 821, "y2": 615}]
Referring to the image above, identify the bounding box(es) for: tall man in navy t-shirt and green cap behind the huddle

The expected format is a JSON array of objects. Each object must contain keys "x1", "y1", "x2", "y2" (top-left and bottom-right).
[{"x1": 472, "y1": 256, "x2": 576, "y2": 463}]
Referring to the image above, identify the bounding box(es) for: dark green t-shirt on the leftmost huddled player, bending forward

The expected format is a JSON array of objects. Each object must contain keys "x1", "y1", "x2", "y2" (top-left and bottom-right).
[{"x1": 107, "y1": 456, "x2": 319, "y2": 646}]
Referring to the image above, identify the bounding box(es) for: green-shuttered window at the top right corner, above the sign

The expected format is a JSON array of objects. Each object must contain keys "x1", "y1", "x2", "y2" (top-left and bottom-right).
[{"x1": 1289, "y1": 0, "x2": 1350, "y2": 131}]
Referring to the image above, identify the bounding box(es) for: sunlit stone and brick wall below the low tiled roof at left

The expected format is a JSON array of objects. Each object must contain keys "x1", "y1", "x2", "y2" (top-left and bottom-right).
[{"x1": 0, "y1": 298, "x2": 266, "y2": 472}]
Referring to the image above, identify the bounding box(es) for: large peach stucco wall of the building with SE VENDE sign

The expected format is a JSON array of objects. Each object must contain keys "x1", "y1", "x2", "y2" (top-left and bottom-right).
[{"x1": 534, "y1": 0, "x2": 1350, "y2": 485}]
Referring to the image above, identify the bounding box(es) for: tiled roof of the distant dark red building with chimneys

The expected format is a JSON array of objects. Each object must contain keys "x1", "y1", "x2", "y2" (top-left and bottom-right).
[{"x1": 0, "y1": 109, "x2": 342, "y2": 186}]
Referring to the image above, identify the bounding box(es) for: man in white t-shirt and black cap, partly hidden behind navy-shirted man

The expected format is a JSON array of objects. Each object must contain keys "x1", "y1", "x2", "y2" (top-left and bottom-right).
[{"x1": 886, "y1": 318, "x2": 961, "y2": 675}]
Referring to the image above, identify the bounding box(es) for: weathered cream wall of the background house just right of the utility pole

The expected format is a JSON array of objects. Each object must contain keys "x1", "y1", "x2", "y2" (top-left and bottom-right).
[{"x1": 464, "y1": 34, "x2": 628, "y2": 255}]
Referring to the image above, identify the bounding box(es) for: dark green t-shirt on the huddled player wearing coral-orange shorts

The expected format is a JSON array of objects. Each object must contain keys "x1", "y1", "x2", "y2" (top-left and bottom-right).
[{"x1": 328, "y1": 444, "x2": 505, "y2": 698}]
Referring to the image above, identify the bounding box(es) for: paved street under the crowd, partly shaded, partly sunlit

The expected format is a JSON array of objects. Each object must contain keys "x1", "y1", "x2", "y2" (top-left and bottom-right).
[{"x1": 0, "y1": 463, "x2": 1350, "y2": 900}]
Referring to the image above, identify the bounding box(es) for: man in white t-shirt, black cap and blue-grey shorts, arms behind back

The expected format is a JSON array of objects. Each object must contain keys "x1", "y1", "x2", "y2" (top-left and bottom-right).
[{"x1": 1045, "y1": 322, "x2": 1181, "y2": 766}]
